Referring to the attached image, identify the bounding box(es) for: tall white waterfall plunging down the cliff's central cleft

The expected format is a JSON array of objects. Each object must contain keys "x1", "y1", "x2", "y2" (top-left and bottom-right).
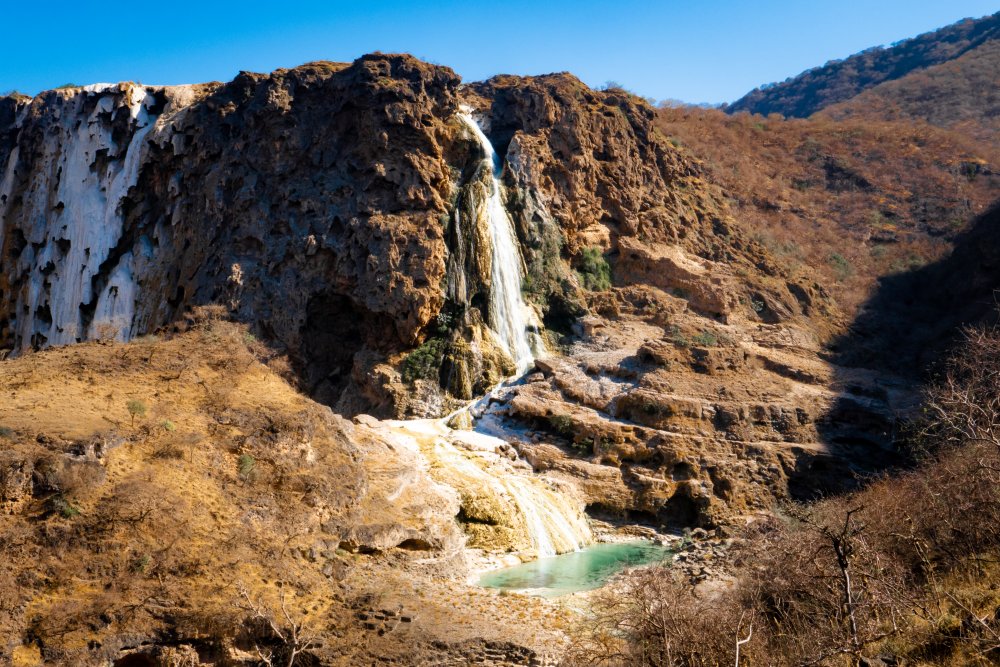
[{"x1": 458, "y1": 107, "x2": 542, "y2": 375}]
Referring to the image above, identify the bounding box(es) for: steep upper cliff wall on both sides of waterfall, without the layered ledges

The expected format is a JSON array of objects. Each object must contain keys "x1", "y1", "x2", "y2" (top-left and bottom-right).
[{"x1": 0, "y1": 55, "x2": 820, "y2": 415}]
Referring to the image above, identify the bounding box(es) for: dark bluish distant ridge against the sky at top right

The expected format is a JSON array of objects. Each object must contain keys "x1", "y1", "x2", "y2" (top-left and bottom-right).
[{"x1": 725, "y1": 14, "x2": 1000, "y2": 118}]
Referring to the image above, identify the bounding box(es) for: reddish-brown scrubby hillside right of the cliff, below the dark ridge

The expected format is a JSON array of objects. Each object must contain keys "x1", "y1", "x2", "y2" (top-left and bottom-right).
[{"x1": 657, "y1": 107, "x2": 1000, "y2": 317}]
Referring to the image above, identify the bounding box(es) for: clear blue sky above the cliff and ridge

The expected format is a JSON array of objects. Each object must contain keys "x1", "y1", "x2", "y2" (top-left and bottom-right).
[{"x1": 0, "y1": 0, "x2": 1000, "y2": 103}]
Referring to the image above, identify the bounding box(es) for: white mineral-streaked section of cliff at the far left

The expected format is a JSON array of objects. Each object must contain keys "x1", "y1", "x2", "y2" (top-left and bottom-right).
[{"x1": 0, "y1": 84, "x2": 203, "y2": 349}]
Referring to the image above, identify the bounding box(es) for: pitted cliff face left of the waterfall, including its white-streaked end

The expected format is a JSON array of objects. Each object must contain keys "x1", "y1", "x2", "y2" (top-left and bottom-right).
[{"x1": 0, "y1": 56, "x2": 458, "y2": 412}]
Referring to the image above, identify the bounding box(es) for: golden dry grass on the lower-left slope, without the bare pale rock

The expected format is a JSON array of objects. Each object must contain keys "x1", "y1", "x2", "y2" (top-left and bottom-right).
[{"x1": 0, "y1": 317, "x2": 356, "y2": 662}]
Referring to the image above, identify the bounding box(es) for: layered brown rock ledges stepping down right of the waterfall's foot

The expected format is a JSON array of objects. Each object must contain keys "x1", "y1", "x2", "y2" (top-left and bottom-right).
[{"x1": 498, "y1": 286, "x2": 908, "y2": 528}]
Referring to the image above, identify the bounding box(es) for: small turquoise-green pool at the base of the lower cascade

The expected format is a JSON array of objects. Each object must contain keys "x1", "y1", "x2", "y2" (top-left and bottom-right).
[{"x1": 479, "y1": 540, "x2": 674, "y2": 598}]
